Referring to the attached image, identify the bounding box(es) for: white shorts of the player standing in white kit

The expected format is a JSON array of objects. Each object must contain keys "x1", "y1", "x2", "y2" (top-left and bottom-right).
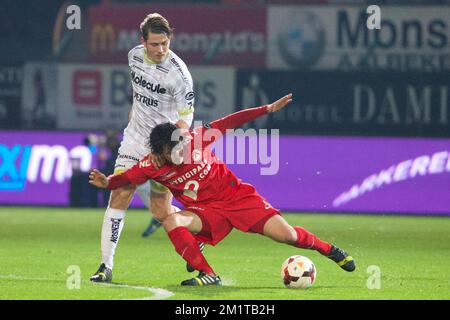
[{"x1": 114, "y1": 128, "x2": 169, "y2": 193}]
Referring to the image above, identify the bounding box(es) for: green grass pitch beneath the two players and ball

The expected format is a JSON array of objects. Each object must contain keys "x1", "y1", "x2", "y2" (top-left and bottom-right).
[{"x1": 0, "y1": 207, "x2": 450, "y2": 300}]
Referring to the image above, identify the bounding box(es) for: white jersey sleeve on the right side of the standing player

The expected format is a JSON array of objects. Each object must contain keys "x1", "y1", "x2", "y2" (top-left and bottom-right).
[{"x1": 174, "y1": 68, "x2": 195, "y2": 126}]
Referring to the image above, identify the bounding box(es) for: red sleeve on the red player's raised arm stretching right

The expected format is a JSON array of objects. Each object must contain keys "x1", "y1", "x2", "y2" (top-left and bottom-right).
[{"x1": 191, "y1": 105, "x2": 269, "y2": 148}]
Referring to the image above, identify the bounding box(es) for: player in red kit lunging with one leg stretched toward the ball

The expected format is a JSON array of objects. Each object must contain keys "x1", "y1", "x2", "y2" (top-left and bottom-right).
[{"x1": 89, "y1": 94, "x2": 355, "y2": 286}]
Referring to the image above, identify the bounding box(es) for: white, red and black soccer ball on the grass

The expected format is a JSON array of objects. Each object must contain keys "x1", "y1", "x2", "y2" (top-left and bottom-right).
[{"x1": 281, "y1": 256, "x2": 317, "y2": 289}]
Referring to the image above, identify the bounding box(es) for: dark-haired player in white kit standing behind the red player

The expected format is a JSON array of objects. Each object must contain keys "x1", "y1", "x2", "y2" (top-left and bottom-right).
[{"x1": 90, "y1": 13, "x2": 194, "y2": 282}]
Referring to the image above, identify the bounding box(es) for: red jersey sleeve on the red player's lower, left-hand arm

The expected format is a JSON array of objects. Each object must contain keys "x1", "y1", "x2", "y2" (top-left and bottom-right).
[{"x1": 108, "y1": 156, "x2": 157, "y2": 190}]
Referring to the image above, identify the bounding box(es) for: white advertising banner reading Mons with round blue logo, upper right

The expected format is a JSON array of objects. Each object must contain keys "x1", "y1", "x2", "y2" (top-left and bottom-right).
[{"x1": 267, "y1": 6, "x2": 450, "y2": 72}]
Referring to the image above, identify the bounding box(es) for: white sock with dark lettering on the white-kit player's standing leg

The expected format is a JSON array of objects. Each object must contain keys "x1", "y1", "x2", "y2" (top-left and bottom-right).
[{"x1": 102, "y1": 207, "x2": 125, "y2": 269}]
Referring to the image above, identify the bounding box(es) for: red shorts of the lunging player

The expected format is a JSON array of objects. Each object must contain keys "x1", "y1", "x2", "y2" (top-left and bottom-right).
[{"x1": 184, "y1": 183, "x2": 280, "y2": 246}]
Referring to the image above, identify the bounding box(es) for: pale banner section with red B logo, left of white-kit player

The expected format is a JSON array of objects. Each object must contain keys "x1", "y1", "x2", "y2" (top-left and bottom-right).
[{"x1": 58, "y1": 64, "x2": 132, "y2": 130}]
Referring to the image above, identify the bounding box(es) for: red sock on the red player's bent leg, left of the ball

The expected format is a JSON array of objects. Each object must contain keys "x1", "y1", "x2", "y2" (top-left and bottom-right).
[{"x1": 167, "y1": 227, "x2": 215, "y2": 275}]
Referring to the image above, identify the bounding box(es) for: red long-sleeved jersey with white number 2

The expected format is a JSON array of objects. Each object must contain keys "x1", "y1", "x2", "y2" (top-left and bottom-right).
[{"x1": 108, "y1": 106, "x2": 268, "y2": 207}]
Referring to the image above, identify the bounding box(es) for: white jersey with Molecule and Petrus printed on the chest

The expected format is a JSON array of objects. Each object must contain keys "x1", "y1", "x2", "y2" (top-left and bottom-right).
[{"x1": 125, "y1": 45, "x2": 194, "y2": 142}]
